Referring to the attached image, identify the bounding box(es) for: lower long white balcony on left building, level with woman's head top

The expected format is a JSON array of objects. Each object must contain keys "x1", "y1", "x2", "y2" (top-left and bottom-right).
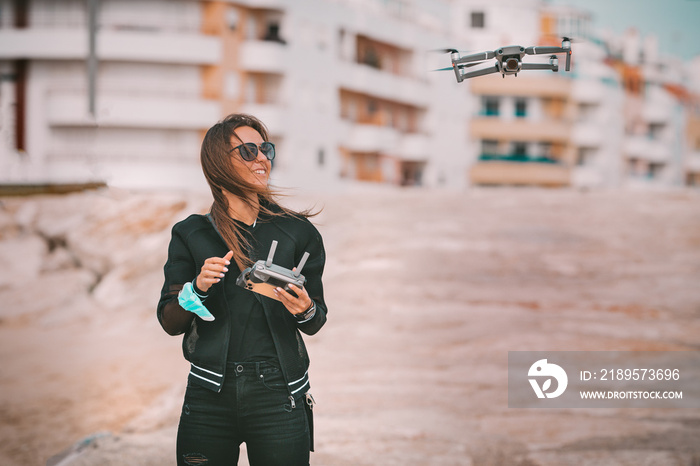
[{"x1": 47, "y1": 94, "x2": 221, "y2": 129}]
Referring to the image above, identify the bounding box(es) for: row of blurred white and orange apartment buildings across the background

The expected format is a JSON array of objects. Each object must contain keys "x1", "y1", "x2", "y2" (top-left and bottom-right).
[{"x1": 0, "y1": 0, "x2": 700, "y2": 190}]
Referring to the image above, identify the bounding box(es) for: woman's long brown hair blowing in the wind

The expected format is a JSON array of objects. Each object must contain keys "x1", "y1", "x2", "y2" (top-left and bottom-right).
[{"x1": 200, "y1": 113, "x2": 316, "y2": 270}]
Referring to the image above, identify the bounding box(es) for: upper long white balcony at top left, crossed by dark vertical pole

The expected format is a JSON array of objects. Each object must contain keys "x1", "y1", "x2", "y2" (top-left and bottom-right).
[{"x1": 0, "y1": 28, "x2": 221, "y2": 65}]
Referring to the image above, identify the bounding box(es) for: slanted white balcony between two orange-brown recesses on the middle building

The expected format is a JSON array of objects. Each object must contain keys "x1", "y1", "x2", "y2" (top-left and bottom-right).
[{"x1": 338, "y1": 62, "x2": 430, "y2": 107}]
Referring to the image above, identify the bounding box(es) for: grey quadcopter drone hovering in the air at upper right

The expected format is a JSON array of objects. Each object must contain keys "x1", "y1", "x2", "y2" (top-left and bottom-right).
[{"x1": 435, "y1": 37, "x2": 571, "y2": 83}]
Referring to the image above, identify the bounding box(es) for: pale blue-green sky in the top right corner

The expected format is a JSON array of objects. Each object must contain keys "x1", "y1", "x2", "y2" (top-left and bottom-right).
[{"x1": 549, "y1": 0, "x2": 700, "y2": 60}]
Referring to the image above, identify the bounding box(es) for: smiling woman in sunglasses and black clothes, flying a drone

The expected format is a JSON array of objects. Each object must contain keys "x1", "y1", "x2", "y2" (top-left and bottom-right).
[{"x1": 158, "y1": 114, "x2": 326, "y2": 466}]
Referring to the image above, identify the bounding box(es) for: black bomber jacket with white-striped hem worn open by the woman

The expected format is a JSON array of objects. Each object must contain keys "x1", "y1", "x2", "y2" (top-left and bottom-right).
[{"x1": 157, "y1": 208, "x2": 327, "y2": 403}]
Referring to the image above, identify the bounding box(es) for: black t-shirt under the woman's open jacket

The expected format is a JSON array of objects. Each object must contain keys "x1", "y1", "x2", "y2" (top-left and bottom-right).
[{"x1": 225, "y1": 221, "x2": 278, "y2": 363}]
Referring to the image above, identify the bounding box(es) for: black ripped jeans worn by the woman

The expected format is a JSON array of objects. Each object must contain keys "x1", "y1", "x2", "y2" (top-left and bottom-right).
[{"x1": 177, "y1": 362, "x2": 310, "y2": 466}]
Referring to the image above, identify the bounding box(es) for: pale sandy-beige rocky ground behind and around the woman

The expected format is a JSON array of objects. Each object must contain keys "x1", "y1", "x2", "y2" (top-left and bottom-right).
[{"x1": 0, "y1": 188, "x2": 700, "y2": 466}]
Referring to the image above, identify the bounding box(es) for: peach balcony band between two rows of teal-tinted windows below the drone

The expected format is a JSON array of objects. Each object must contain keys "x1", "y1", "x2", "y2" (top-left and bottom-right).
[{"x1": 470, "y1": 117, "x2": 571, "y2": 143}]
